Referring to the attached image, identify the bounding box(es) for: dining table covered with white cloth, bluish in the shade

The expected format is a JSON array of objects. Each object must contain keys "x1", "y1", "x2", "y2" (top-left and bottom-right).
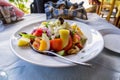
[{"x1": 0, "y1": 13, "x2": 120, "y2": 80}]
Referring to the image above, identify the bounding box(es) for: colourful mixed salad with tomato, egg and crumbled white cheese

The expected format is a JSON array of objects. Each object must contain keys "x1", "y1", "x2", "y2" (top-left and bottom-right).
[{"x1": 18, "y1": 17, "x2": 87, "y2": 56}]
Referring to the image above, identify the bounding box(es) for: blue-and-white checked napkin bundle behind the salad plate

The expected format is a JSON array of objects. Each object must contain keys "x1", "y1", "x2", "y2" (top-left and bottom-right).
[{"x1": 44, "y1": 0, "x2": 87, "y2": 20}]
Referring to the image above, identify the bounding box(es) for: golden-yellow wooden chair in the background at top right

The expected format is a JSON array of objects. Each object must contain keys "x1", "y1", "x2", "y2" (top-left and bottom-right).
[{"x1": 98, "y1": 0, "x2": 116, "y2": 21}]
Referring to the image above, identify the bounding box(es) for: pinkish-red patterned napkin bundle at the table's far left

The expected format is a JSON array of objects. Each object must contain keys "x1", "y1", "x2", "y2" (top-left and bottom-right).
[{"x1": 0, "y1": 0, "x2": 24, "y2": 23}]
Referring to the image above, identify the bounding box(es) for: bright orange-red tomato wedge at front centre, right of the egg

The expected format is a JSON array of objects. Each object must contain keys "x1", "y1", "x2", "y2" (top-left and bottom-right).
[{"x1": 50, "y1": 38, "x2": 62, "y2": 51}]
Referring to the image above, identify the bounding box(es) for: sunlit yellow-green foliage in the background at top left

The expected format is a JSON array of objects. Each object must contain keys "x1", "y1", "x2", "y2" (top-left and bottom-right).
[{"x1": 9, "y1": 0, "x2": 30, "y2": 14}]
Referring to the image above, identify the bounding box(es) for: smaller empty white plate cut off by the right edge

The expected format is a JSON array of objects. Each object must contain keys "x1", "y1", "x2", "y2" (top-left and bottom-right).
[{"x1": 104, "y1": 34, "x2": 120, "y2": 53}]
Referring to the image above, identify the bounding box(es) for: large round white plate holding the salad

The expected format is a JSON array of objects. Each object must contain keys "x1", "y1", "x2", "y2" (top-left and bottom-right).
[{"x1": 10, "y1": 20, "x2": 104, "y2": 67}]
